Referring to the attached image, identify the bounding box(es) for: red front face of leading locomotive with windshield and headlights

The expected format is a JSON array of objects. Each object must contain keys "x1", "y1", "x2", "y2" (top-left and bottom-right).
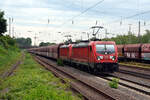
[{"x1": 93, "y1": 41, "x2": 118, "y2": 72}]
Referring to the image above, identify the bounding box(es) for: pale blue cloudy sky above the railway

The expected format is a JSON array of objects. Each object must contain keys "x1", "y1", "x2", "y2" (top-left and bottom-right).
[{"x1": 0, "y1": 0, "x2": 150, "y2": 45}]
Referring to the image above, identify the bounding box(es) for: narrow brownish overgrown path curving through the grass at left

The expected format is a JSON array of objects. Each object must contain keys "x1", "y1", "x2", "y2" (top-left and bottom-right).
[{"x1": 1, "y1": 52, "x2": 25, "y2": 79}]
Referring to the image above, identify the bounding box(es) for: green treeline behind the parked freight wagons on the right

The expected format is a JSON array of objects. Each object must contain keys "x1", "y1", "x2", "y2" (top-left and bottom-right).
[{"x1": 102, "y1": 30, "x2": 150, "y2": 44}]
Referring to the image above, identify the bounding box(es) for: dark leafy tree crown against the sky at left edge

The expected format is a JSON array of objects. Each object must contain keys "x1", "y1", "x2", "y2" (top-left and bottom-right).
[{"x1": 0, "y1": 10, "x2": 7, "y2": 36}]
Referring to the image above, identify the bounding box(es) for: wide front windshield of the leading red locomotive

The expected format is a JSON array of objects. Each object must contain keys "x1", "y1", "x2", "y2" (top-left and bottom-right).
[{"x1": 96, "y1": 44, "x2": 115, "y2": 54}]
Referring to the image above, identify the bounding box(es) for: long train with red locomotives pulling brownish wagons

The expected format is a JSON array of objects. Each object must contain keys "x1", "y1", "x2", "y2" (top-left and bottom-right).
[{"x1": 28, "y1": 41, "x2": 118, "y2": 73}]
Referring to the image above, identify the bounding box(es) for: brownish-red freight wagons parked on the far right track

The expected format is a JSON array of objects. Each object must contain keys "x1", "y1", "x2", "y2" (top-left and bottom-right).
[{"x1": 117, "y1": 43, "x2": 150, "y2": 63}]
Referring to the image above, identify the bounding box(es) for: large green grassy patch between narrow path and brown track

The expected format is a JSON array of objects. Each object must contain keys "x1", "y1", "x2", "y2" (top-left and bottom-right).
[{"x1": 0, "y1": 54, "x2": 82, "y2": 100}]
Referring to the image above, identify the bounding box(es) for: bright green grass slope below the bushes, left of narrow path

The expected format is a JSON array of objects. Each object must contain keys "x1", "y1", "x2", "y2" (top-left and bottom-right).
[{"x1": 0, "y1": 45, "x2": 21, "y2": 75}]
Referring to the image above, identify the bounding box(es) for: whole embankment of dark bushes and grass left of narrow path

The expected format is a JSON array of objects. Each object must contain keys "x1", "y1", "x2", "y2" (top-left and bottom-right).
[{"x1": 0, "y1": 36, "x2": 21, "y2": 75}]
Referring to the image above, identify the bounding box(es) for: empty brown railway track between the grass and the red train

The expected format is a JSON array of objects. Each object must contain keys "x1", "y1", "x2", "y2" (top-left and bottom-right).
[{"x1": 32, "y1": 56, "x2": 136, "y2": 100}]
